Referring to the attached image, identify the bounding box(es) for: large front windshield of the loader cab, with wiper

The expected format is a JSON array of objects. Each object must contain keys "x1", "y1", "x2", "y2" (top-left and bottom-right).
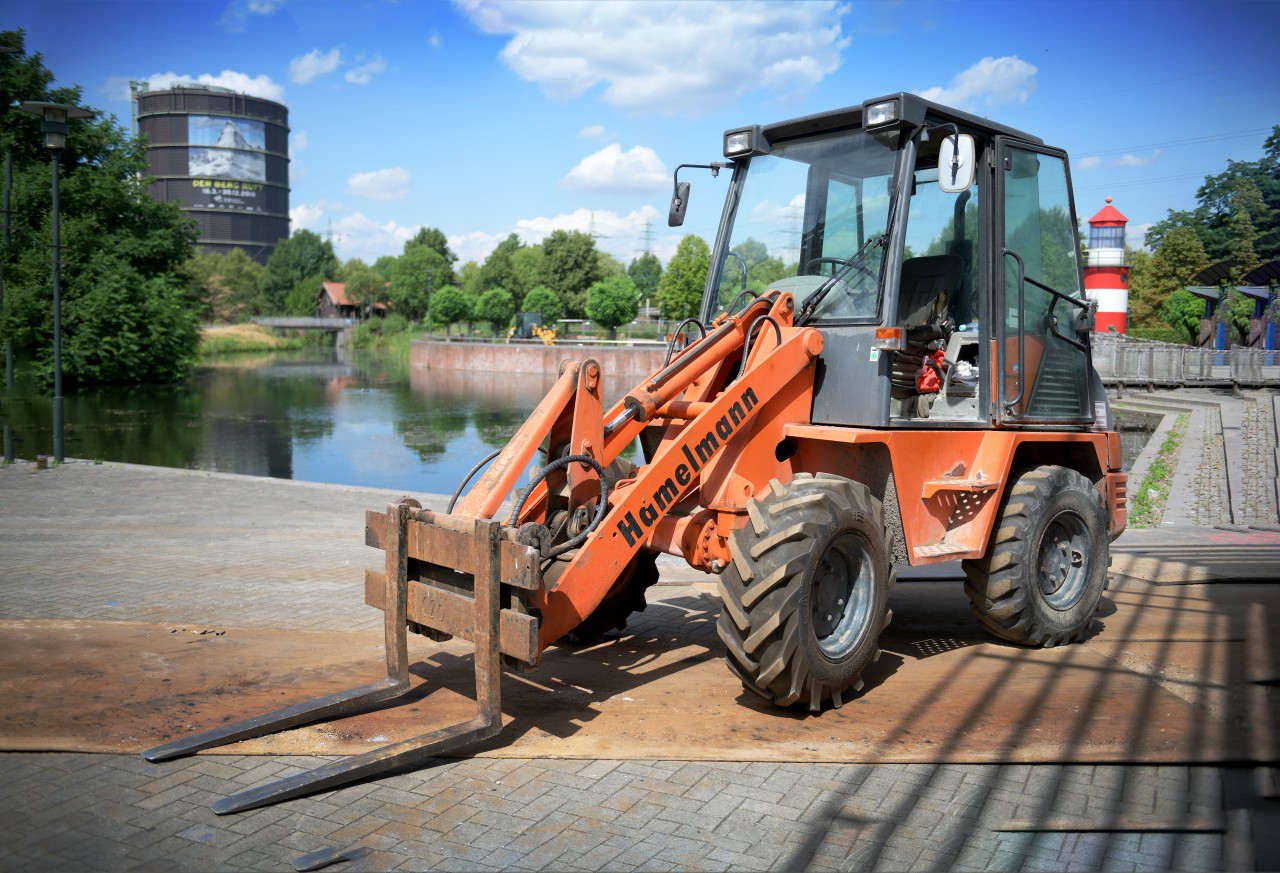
[{"x1": 716, "y1": 129, "x2": 896, "y2": 323}]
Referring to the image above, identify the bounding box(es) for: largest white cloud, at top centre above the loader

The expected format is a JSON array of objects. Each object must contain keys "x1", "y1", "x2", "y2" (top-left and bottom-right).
[{"x1": 454, "y1": 0, "x2": 850, "y2": 115}]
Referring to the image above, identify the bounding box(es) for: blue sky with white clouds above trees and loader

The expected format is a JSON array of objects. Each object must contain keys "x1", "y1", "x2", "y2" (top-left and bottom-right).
[{"x1": 10, "y1": 0, "x2": 1280, "y2": 262}]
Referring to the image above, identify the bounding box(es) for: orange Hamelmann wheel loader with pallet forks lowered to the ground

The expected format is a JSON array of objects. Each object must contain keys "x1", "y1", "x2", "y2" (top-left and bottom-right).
[{"x1": 145, "y1": 93, "x2": 1126, "y2": 813}]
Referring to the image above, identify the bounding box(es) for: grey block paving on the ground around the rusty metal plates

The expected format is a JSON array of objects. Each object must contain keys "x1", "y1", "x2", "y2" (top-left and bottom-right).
[{"x1": 0, "y1": 393, "x2": 1280, "y2": 870}]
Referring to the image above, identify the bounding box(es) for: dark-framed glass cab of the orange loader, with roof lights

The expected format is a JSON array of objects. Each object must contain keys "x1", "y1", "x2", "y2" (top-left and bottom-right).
[{"x1": 703, "y1": 93, "x2": 1105, "y2": 428}]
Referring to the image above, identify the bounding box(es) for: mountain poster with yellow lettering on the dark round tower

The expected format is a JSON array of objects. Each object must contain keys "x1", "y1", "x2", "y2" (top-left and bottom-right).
[{"x1": 187, "y1": 115, "x2": 266, "y2": 212}]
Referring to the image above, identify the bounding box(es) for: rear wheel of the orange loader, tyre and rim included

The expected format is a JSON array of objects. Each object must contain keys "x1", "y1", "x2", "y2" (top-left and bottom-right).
[{"x1": 964, "y1": 466, "x2": 1110, "y2": 646}]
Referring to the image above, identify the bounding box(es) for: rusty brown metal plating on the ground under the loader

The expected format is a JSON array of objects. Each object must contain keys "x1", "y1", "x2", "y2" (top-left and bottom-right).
[{"x1": 0, "y1": 581, "x2": 1280, "y2": 763}]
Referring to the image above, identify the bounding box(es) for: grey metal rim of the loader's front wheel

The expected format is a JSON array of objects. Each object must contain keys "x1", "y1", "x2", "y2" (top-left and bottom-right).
[{"x1": 810, "y1": 534, "x2": 876, "y2": 661}]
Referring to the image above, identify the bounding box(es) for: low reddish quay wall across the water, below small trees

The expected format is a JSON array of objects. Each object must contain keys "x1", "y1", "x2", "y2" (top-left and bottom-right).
[{"x1": 408, "y1": 339, "x2": 667, "y2": 378}]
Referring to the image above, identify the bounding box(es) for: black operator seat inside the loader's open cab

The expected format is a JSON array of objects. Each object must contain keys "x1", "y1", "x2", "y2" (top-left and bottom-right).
[{"x1": 890, "y1": 255, "x2": 964, "y2": 399}]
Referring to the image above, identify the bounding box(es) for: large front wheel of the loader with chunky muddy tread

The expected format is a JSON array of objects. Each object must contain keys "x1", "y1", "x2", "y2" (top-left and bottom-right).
[{"x1": 717, "y1": 474, "x2": 893, "y2": 712}]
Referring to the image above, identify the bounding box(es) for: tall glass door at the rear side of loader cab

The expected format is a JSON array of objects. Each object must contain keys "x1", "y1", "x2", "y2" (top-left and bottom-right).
[{"x1": 992, "y1": 137, "x2": 1093, "y2": 425}]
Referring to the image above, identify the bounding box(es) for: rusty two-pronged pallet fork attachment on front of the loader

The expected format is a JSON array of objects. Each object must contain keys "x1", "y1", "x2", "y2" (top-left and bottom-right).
[{"x1": 142, "y1": 499, "x2": 540, "y2": 815}]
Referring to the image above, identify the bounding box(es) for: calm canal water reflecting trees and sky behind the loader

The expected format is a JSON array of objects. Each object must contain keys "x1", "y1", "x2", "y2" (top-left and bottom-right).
[{"x1": 0, "y1": 349, "x2": 1156, "y2": 494}]
